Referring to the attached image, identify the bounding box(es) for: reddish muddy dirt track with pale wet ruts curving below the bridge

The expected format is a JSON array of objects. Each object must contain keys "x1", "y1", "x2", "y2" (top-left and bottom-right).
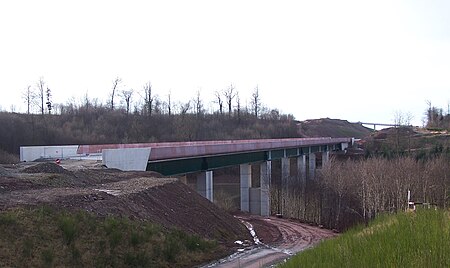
[{"x1": 204, "y1": 215, "x2": 336, "y2": 268}]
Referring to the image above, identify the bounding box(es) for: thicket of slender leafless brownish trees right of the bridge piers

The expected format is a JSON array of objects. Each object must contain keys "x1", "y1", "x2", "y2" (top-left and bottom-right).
[{"x1": 270, "y1": 154, "x2": 450, "y2": 231}]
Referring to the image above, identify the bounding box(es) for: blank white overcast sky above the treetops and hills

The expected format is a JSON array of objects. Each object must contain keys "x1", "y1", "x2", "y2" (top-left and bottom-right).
[{"x1": 0, "y1": 0, "x2": 450, "y2": 125}]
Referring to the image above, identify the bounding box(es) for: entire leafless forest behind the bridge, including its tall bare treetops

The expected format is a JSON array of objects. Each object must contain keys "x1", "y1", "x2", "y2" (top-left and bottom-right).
[{"x1": 0, "y1": 77, "x2": 299, "y2": 154}]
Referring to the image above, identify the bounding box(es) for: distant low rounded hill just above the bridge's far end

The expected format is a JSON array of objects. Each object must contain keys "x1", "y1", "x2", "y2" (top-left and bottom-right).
[{"x1": 297, "y1": 118, "x2": 372, "y2": 139}]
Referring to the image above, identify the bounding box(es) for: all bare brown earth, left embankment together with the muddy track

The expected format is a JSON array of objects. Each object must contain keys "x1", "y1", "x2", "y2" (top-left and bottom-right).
[{"x1": 0, "y1": 160, "x2": 335, "y2": 267}]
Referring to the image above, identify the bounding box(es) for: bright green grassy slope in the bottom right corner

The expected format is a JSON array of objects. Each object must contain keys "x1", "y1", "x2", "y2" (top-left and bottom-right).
[{"x1": 281, "y1": 210, "x2": 450, "y2": 267}]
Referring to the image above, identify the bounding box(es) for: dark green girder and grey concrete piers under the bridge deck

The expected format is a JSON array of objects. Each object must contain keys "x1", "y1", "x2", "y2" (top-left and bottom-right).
[{"x1": 147, "y1": 144, "x2": 346, "y2": 216}]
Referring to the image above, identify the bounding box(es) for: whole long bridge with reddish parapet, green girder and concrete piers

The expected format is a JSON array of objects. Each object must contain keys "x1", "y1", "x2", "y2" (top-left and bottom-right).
[{"x1": 20, "y1": 138, "x2": 353, "y2": 216}]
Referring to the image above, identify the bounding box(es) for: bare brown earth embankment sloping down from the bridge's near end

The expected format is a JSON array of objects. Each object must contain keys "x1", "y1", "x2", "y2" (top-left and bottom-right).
[{"x1": 0, "y1": 163, "x2": 249, "y2": 246}]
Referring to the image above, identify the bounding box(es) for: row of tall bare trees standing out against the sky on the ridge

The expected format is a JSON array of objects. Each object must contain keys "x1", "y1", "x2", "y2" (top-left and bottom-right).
[{"x1": 17, "y1": 77, "x2": 268, "y2": 118}]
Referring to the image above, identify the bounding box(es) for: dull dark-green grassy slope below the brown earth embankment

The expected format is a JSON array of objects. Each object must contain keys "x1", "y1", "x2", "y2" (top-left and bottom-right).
[{"x1": 0, "y1": 206, "x2": 221, "y2": 267}]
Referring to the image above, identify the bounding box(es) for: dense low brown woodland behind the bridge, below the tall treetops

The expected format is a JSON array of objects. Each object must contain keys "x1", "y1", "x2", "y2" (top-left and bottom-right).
[{"x1": 0, "y1": 94, "x2": 298, "y2": 154}]
